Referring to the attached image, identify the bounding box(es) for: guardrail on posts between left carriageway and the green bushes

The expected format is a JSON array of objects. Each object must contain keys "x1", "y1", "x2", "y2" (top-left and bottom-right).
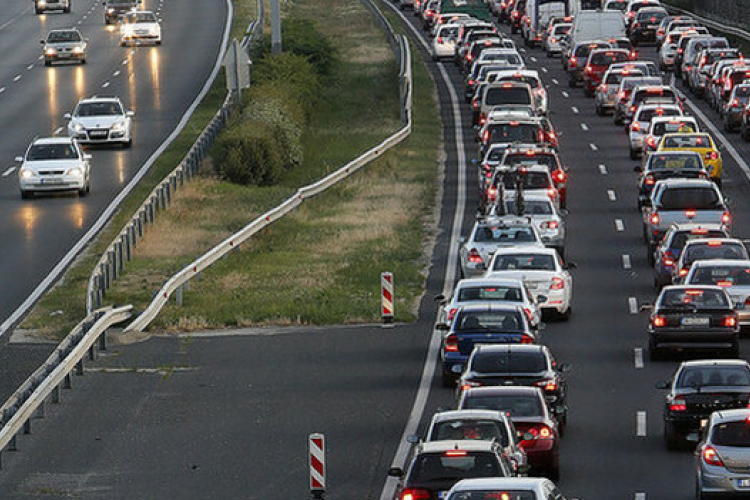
[{"x1": 86, "y1": 7, "x2": 263, "y2": 313}]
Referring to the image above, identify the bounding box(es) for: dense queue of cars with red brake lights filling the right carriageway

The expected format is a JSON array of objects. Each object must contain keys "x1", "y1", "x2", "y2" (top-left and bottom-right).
[{"x1": 389, "y1": 0, "x2": 750, "y2": 500}]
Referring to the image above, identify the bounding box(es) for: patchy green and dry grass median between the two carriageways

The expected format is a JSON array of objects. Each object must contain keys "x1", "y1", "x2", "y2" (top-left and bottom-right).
[{"x1": 22, "y1": 0, "x2": 441, "y2": 338}]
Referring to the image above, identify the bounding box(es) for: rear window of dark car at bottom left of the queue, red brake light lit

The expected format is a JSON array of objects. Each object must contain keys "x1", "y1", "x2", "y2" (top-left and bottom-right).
[{"x1": 408, "y1": 450, "x2": 504, "y2": 483}]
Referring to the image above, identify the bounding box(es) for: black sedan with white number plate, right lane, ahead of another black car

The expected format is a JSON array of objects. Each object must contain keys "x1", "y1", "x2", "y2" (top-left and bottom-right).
[{"x1": 643, "y1": 284, "x2": 740, "y2": 361}]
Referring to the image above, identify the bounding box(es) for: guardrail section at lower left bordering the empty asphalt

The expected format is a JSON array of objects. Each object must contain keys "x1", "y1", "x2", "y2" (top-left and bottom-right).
[{"x1": 0, "y1": 306, "x2": 132, "y2": 468}]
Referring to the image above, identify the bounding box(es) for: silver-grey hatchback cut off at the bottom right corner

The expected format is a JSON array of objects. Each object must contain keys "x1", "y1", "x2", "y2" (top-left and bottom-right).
[{"x1": 695, "y1": 408, "x2": 750, "y2": 500}]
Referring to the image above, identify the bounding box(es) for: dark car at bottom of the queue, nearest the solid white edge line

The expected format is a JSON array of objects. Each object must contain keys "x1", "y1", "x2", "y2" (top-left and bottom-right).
[{"x1": 388, "y1": 440, "x2": 514, "y2": 500}]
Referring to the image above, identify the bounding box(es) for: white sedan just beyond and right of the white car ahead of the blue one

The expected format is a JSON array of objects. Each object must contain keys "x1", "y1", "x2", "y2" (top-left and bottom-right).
[{"x1": 485, "y1": 247, "x2": 575, "y2": 320}]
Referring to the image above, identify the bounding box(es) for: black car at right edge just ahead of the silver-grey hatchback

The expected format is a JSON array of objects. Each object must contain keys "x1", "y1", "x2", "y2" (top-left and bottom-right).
[{"x1": 657, "y1": 360, "x2": 750, "y2": 449}]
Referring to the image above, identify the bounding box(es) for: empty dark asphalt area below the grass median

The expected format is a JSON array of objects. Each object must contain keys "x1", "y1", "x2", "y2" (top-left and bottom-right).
[{"x1": 0, "y1": 325, "x2": 429, "y2": 500}]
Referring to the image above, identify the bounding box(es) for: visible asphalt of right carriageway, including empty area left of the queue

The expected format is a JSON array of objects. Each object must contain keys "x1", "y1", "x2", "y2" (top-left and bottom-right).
[{"x1": 0, "y1": 0, "x2": 750, "y2": 500}]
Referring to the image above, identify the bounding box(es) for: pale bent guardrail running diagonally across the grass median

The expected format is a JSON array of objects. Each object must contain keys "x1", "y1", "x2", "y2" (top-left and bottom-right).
[{"x1": 125, "y1": 0, "x2": 412, "y2": 331}]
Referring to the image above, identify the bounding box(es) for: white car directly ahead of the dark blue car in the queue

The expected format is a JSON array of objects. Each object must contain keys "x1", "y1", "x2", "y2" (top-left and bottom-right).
[{"x1": 435, "y1": 278, "x2": 541, "y2": 328}]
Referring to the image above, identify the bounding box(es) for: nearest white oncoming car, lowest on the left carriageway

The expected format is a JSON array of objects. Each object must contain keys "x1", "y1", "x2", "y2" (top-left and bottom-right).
[{"x1": 16, "y1": 137, "x2": 91, "y2": 199}]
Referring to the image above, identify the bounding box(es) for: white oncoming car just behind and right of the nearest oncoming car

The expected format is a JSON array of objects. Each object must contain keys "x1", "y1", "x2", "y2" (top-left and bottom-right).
[{"x1": 64, "y1": 95, "x2": 135, "y2": 147}]
